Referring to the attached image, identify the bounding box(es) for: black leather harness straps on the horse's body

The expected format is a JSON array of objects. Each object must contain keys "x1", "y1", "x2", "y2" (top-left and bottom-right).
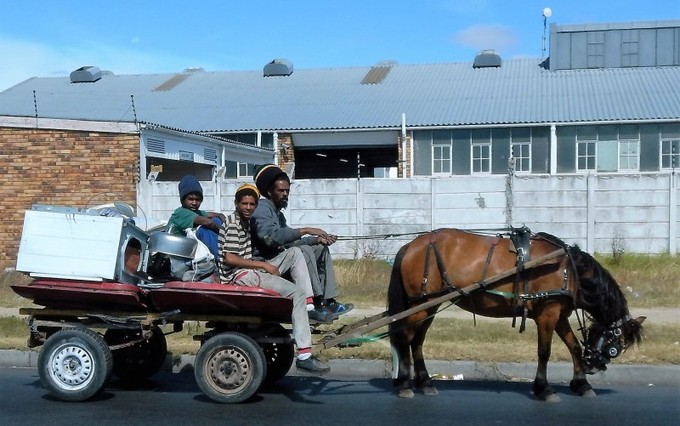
[{"x1": 411, "y1": 230, "x2": 574, "y2": 333}]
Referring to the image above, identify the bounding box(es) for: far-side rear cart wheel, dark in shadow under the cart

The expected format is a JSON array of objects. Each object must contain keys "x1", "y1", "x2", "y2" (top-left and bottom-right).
[{"x1": 104, "y1": 326, "x2": 168, "y2": 382}]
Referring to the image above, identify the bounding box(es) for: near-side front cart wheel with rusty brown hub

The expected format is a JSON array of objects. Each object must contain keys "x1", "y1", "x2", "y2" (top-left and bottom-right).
[{"x1": 194, "y1": 332, "x2": 267, "y2": 403}]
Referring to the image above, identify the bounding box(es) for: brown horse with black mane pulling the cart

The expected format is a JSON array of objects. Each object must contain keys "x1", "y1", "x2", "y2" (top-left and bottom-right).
[{"x1": 388, "y1": 228, "x2": 645, "y2": 401}]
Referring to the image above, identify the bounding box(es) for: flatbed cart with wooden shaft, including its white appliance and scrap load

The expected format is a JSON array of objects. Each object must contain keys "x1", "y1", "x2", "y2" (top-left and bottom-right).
[{"x1": 11, "y1": 205, "x2": 564, "y2": 403}]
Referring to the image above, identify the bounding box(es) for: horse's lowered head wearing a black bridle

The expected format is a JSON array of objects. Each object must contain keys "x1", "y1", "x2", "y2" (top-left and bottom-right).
[{"x1": 583, "y1": 315, "x2": 647, "y2": 374}]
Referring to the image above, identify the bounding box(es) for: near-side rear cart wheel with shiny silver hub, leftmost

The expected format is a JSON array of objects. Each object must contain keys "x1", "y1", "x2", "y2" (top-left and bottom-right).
[{"x1": 38, "y1": 328, "x2": 113, "y2": 401}]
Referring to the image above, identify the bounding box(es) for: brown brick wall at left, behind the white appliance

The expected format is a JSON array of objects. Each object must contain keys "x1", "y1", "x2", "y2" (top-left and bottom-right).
[{"x1": 0, "y1": 127, "x2": 139, "y2": 267}]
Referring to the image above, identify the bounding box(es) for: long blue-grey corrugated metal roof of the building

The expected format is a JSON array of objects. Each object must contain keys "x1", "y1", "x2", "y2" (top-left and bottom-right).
[{"x1": 0, "y1": 58, "x2": 680, "y2": 132}]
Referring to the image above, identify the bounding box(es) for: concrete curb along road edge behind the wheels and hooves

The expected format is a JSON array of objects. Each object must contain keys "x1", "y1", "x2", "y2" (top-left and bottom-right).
[{"x1": 0, "y1": 349, "x2": 680, "y2": 386}]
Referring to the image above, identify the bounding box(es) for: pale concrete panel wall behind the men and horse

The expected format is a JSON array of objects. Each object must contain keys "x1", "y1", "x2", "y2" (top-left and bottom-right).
[{"x1": 140, "y1": 174, "x2": 678, "y2": 258}]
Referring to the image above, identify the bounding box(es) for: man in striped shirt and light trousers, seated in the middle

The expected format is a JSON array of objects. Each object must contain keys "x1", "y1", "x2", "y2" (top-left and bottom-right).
[{"x1": 219, "y1": 184, "x2": 330, "y2": 373}]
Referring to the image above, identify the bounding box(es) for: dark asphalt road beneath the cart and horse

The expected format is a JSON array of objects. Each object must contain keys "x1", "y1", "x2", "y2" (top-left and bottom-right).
[{"x1": 0, "y1": 367, "x2": 680, "y2": 426}]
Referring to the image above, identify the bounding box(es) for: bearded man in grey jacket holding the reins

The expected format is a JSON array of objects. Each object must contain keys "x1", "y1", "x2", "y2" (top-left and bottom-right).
[{"x1": 251, "y1": 164, "x2": 354, "y2": 315}]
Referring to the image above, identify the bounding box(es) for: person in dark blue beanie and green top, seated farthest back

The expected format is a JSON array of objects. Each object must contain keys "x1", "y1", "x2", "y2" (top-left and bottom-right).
[{"x1": 168, "y1": 175, "x2": 224, "y2": 260}]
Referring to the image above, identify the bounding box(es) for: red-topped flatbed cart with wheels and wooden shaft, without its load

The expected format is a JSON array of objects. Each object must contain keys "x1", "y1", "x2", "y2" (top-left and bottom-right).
[{"x1": 12, "y1": 246, "x2": 564, "y2": 403}]
